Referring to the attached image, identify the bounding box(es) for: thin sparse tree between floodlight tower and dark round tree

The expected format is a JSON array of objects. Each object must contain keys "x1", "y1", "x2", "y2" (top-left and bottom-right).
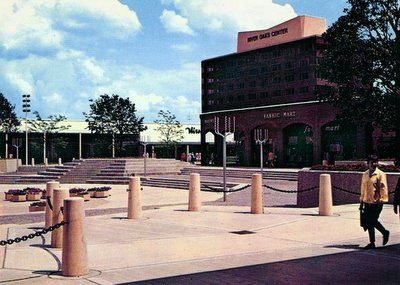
[{"x1": 28, "y1": 111, "x2": 71, "y2": 162}]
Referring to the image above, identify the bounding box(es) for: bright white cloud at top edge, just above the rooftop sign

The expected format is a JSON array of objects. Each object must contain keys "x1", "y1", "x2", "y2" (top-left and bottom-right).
[{"x1": 162, "y1": 0, "x2": 296, "y2": 32}]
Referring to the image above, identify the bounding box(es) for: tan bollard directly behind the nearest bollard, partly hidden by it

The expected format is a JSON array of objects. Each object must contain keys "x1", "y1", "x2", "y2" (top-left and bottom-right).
[{"x1": 51, "y1": 188, "x2": 69, "y2": 248}]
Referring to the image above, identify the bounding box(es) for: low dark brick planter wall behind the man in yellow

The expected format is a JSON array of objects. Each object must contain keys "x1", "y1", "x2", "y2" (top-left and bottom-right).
[{"x1": 297, "y1": 169, "x2": 400, "y2": 208}]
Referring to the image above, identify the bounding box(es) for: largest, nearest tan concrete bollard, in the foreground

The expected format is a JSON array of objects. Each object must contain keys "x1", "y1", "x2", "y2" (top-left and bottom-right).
[{"x1": 61, "y1": 197, "x2": 89, "y2": 277}]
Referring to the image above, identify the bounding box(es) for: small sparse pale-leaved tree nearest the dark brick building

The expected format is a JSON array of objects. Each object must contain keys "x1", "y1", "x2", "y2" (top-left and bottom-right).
[{"x1": 154, "y1": 110, "x2": 183, "y2": 158}]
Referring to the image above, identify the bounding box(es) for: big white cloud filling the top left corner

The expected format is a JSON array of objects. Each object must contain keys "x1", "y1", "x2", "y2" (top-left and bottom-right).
[{"x1": 0, "y1": 0, "x2": 141, "y2": 56}]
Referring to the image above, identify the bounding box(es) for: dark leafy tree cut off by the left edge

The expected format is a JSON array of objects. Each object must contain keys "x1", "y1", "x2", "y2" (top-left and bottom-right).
[{"x1": 0, "y1": 93, "x2": 21, "y2": 157}]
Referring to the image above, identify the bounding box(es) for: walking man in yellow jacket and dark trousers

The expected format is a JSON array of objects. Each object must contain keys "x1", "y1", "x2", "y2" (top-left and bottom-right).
[{"x1": 360, "y1": 155, "x2": 389, "y2": 249}]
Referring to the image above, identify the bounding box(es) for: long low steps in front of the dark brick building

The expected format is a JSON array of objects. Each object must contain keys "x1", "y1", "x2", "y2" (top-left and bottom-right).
[{"x1": 180, "y1": 167, "x2": 298, "y2": 181}]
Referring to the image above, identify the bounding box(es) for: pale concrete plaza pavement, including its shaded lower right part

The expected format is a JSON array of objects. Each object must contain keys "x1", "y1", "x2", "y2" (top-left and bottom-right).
[{"x1": 0, "y1": 181, "x2": 400, "y2": 284}]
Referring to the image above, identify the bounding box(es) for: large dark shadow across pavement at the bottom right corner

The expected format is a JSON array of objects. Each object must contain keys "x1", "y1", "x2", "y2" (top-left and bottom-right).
[{"x1": 124, "y1": 244, "x2": 400, "y2": 285}]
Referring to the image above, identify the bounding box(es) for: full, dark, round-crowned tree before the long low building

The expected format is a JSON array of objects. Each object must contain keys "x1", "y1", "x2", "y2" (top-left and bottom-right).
[{"x1": 83, "y1": 94, "x2": 146, "y2": 157}]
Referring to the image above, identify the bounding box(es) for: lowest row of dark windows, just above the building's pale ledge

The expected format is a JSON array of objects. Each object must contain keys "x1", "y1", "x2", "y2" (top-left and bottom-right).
[{"x1": 207, "y1": 86, "x2": 309, "y2": 106}]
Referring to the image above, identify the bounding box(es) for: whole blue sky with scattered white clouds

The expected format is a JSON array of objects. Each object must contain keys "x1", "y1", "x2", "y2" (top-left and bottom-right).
[{"x1": 0, "y1": 0, "x2": 346, "y2": 123}]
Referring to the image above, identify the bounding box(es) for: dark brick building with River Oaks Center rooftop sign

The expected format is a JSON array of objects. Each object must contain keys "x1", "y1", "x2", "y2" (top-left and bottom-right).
[{"x1": 200, "y1": 16, "x2": 379, "y2": 166}]
